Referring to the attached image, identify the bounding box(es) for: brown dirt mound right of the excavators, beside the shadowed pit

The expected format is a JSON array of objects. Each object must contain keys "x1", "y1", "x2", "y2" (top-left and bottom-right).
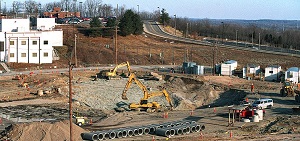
[{"x1": 165, "y1": 76, "x2": 222, "y2": 110}]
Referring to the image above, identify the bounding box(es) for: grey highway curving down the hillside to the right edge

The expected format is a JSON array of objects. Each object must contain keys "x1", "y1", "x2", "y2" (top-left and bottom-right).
[{"x1": 144, "y1": 21, "x2": 300, "y2": 57}]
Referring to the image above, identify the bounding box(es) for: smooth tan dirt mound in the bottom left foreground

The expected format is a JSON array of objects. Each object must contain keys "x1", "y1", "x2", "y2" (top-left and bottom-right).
[{"x1": 10, "y1": 120, "x2": 86, "y2": 141}]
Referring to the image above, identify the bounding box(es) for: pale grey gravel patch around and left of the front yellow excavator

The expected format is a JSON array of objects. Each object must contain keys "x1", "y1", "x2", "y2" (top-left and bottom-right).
[{"x1": 73, "y1": 78, "x2": 168, "y2": 110}]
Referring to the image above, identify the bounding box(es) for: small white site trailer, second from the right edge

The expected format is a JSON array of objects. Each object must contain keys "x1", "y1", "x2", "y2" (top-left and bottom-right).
[{"x1": 265, "y1": 65, "x2": 281, "y2": 81}]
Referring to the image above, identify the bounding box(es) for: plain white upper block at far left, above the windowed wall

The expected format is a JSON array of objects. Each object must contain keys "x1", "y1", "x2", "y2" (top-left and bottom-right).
[{"x1": 0, "y1": 19, "x2": 30, "y2": 32}]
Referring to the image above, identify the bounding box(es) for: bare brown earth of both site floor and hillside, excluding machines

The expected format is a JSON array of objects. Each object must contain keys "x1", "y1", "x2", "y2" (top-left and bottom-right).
[{"x1": 0, "y1": 24, "x2": 300, "y2": 141}]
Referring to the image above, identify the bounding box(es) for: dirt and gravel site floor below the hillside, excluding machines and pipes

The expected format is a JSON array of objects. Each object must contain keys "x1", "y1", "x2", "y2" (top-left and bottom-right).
[{"x1": 0, "y1": 68, "x2": 300, "y2": 141}]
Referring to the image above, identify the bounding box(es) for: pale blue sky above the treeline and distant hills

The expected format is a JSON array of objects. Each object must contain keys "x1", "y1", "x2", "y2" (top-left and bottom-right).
[{"x1": 0, "y1": 0, "x2": 300, "y2": 20}]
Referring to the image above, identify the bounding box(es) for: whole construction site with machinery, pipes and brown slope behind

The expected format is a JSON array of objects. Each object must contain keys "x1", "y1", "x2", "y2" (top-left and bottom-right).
[{"x1": 0, "y1": 23, "x2": 300, "y2": 141}]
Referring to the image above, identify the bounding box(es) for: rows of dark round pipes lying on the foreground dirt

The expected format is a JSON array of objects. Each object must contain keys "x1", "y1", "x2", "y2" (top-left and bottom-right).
[{"x1": 81, "y1": 120, "x2": 205, "y2": 141}]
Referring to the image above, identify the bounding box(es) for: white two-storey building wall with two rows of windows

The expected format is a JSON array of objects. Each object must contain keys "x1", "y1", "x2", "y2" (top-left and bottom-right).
[{"x1": 0, "y1": 31, "x2": 63, "y2": 63}]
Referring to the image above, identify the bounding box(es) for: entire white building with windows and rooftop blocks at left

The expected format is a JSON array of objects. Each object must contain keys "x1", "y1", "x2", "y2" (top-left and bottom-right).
[{"x1": 0, "y1": 18, "x2": 63, "y2": 64}]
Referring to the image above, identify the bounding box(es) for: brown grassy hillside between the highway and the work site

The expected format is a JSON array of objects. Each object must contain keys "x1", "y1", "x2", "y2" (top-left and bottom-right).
[{"x1": 10, "y1": 25, "x2": 300, "y2": 68}]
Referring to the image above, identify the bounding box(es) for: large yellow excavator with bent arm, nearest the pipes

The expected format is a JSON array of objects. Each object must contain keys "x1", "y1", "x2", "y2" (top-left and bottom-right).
[{"x1": 122, "y1": 73, "x2": 173, "y2": 112}]
